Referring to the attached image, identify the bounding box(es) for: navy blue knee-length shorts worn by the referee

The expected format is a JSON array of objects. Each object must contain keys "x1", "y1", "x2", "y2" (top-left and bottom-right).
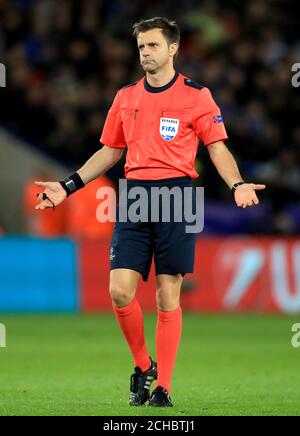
[{"x1": 110, "y1": 177, "x2": 196, "y2": 281}]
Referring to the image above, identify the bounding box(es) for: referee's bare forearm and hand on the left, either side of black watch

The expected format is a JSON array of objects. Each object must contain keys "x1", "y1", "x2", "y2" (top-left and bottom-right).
[{"x1": 35, "y1": 145, "x2": 124, "y2": 210}]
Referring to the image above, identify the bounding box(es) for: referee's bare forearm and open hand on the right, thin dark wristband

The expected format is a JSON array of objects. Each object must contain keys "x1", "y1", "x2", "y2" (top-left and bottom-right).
[{"x1": 207, "y1": 141, "x2": 266, "y2": 208}]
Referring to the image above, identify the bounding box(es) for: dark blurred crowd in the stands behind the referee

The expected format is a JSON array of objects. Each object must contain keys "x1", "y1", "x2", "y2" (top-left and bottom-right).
[{"x1": 0, "y1": 0, "x2": 300, "y2": 233}]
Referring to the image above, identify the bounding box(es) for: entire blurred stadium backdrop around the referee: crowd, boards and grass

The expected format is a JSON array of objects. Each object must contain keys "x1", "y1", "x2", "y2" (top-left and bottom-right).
[{"x1": 0, "y1": 0, "x2": 300, "y2": 415}]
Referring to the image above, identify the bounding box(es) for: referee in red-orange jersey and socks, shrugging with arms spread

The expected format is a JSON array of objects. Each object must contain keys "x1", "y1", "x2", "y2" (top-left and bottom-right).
[{"x1": 36, "y1": 17, "x2": 265, "y2": 407}]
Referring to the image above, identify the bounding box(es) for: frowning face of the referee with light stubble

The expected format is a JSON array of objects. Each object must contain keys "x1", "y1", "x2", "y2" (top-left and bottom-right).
[{"x1": 137, "y1": 29, "x2": 177, "y2": 74}]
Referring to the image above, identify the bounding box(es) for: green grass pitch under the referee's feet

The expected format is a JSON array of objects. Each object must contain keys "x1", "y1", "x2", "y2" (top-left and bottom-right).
[{"x1": 0, "y1": 313, "x2": 300, "y2": 416}]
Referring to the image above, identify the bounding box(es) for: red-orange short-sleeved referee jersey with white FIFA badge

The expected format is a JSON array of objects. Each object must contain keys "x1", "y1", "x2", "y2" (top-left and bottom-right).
[{"x1": 100, "y1": 73, "x2": 227, "y2": 180}]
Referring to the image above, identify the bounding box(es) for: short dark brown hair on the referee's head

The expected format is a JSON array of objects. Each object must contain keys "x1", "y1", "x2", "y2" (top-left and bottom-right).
[{"x1": 132, "y1": 17, "x2": 180, "y2": 44}]
